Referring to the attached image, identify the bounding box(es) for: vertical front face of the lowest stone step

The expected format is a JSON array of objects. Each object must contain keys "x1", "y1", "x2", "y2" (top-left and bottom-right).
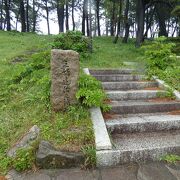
[{"x1": 96, "y1": 145, "x2": 180, "y2": 167}]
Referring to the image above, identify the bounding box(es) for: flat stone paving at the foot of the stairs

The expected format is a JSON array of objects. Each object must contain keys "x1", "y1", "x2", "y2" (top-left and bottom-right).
[{"x1": 6, "y1": 162, "x2": 180, "y2": 180}]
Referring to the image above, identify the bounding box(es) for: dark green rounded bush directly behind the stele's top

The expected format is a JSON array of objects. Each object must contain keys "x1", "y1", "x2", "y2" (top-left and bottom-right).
[{"x1": 51, "y1": 31, "x2": 90, "y2": 53}]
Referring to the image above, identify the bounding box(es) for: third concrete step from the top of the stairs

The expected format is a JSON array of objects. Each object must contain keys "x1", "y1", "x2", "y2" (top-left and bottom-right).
[{"x1": 102, "y1": 81, "x2": 158, "y2": 90}]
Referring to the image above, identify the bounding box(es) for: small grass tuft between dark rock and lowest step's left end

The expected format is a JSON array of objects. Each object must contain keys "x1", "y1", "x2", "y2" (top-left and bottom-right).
[{"x1": 82, "y1": 146, "x2": 96, "y2": 168}]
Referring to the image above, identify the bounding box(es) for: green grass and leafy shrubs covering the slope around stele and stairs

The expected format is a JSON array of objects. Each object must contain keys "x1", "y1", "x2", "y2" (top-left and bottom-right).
[{"x1": 0, "y1": 28, "x2": 179, "y2": 173}]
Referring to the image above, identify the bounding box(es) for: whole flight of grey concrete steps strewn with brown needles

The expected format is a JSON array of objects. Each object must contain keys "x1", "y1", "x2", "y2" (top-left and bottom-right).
[{"x1": 90, "y1": 69, "x2": 180, "y2": 166}]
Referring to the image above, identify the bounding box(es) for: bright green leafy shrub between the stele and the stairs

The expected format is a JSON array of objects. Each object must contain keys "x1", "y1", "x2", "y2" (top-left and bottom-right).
[{"x1": 76, "y1": 74, "x2": 110, "y2": 111}]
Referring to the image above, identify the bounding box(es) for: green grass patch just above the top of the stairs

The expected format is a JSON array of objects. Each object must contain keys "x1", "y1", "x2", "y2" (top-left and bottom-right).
[{"x1": 82, "y1": 37, "x2": 143, "y2": 68}]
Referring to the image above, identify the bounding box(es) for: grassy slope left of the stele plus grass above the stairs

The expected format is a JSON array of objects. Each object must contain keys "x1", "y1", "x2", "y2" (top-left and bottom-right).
[{"x1": 0, "y1": 32, "x2": 179, "y2": 172}]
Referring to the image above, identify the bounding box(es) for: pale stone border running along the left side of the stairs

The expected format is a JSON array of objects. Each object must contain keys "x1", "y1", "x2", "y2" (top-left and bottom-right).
[{"x1": 83, "y1": 68, "x2": 112, "y2": 151}]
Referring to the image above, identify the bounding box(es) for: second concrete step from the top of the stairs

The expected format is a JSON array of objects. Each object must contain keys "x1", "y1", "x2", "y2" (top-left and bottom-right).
[{"x1": 94, "y1": 74, "x2": 144, "y2": 82}]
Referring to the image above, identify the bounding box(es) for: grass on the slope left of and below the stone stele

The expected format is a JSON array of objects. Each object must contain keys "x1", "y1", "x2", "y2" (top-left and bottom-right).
[{"x1": 0, "y1": 32, "x2": 94, "y2": 174}]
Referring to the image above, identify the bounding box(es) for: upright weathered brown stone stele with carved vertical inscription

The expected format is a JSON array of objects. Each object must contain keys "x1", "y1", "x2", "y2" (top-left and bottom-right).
[{"x1": 51, "y1": 49, "x2": 80, "y2": 111}]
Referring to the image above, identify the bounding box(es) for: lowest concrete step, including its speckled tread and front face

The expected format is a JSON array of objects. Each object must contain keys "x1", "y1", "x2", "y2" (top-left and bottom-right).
[{"x1": 100, "y1": 130, "x2": 180, "y2": 166}]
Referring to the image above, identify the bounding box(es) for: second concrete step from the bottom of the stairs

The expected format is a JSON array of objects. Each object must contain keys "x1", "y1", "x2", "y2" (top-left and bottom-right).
[{"x1": 106, "y1": 113, "x2": 180, "y2": 134}]
